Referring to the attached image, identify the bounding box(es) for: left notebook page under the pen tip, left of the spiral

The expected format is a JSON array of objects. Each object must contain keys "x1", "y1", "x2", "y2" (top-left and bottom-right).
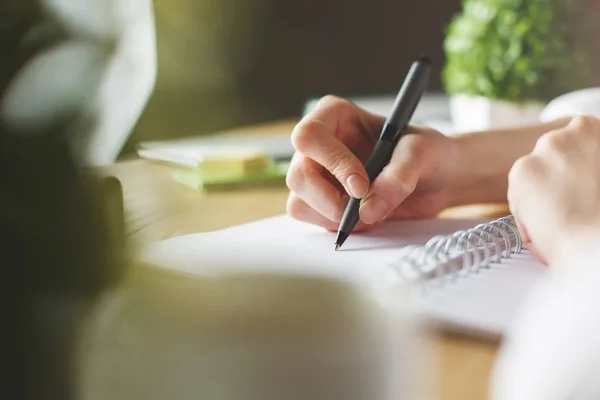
[{"x1": 140, "y1": 215, "x2": 486, "y2": 283}]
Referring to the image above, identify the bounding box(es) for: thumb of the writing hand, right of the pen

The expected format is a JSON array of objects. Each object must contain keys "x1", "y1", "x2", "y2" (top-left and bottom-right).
[{"x1": 360, "y1": 136, "x2": 423, "y2": 224}]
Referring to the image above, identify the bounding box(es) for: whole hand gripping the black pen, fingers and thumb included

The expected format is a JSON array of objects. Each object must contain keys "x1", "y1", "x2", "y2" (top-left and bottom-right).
[{"x1": 287, "y1": 96, "x2": 459, "y2": 230}]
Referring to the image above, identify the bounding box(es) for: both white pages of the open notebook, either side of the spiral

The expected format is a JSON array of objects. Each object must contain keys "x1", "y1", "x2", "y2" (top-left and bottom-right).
[{"x1": 139, "y1": 216, "x2": 546, "y2": 336}]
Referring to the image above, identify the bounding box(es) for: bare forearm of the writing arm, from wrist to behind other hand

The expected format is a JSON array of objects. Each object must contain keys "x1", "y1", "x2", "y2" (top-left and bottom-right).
[{"x1": 451, "y1": 118, "x2": 570, "y2": 206}]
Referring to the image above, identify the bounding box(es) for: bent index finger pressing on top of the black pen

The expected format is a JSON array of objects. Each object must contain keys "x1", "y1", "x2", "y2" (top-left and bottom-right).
[{"x1": 292, "y1": 98, "x2": 369, "y2": 198}]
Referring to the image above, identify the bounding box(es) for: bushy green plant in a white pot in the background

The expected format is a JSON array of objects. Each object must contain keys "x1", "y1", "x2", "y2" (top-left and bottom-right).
[{"x1": 442, "y1": 0, "x2": 588, "y2": 131}]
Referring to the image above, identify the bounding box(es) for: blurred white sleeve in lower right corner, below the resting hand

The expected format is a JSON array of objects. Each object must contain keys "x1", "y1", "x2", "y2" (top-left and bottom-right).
[{"x1": 490, "y1": 250, "x2": 600, "y2": 400}]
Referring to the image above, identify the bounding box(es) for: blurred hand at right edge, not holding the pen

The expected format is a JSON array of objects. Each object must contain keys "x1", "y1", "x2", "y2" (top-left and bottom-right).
[{"x1": 508, "y1": 117, "x2": 600, "y2": 265}]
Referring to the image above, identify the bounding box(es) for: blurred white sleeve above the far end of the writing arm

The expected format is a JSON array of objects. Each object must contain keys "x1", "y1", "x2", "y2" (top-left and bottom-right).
[{"x1": 540, "y1": 87, "x2": 600, "y2": 122}]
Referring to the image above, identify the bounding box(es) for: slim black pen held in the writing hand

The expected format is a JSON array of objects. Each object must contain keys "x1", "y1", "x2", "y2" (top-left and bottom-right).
[{"x1": 335, "y1": 57, "x2": 431, "y2": 251}]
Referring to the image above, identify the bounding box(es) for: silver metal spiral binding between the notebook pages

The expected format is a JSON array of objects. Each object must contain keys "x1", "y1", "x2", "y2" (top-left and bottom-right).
[{"x1": 391, "y1": 216, "x2": 523, "y2": 281}]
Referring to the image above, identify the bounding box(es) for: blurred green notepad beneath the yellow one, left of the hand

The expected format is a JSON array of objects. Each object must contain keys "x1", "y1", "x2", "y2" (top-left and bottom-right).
[{"x1": 173, "y1": 161, "x2": 290, "y2": 191}]
